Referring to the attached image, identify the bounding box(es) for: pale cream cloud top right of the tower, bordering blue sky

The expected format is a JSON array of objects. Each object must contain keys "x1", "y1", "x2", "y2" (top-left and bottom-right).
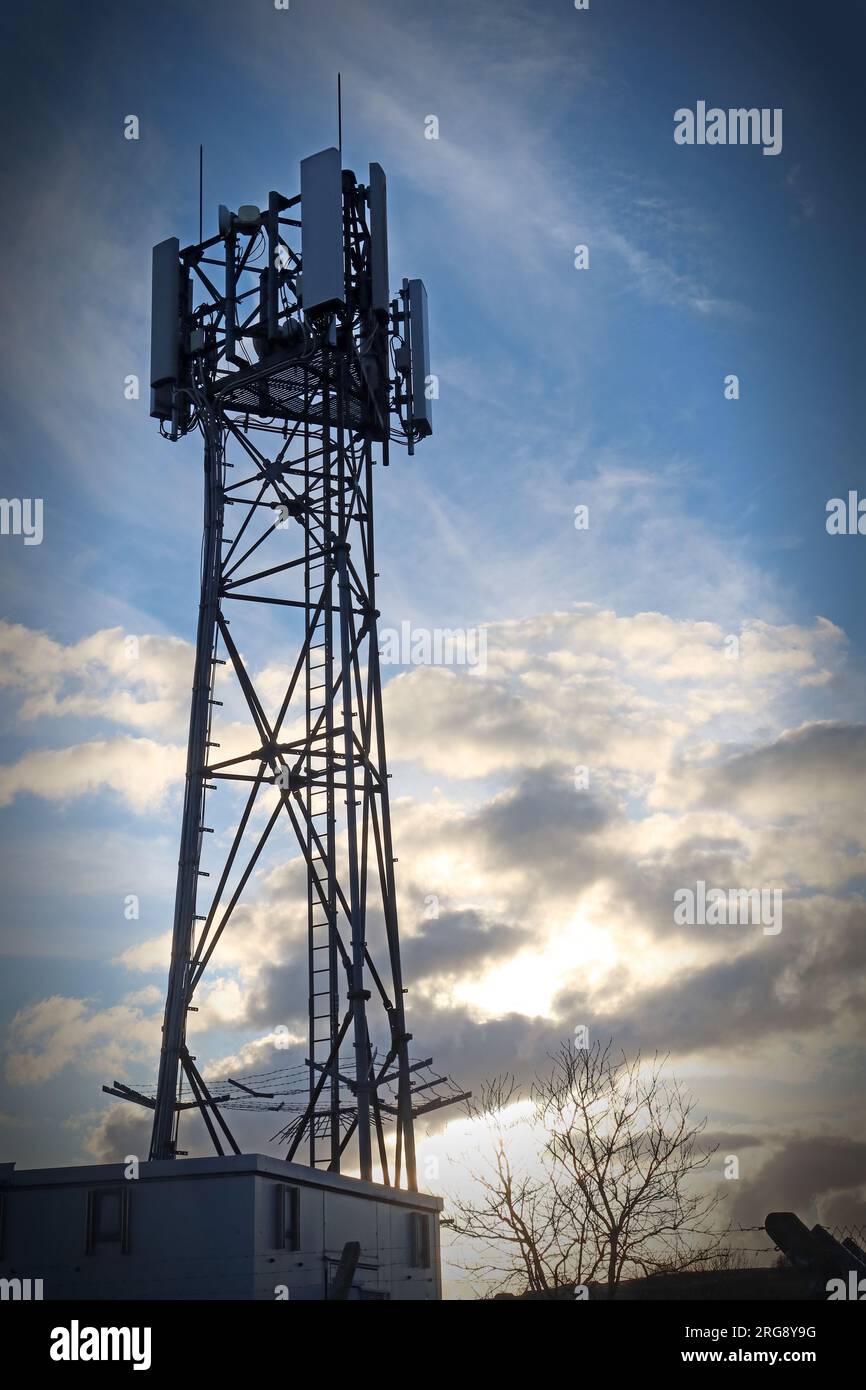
[{"x1": 385, "y1": 605, "x2": 841, "y2": 778}]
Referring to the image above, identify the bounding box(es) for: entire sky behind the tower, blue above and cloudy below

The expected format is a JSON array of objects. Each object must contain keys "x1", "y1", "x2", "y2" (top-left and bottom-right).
[{"x1": 0, "y1": 0, "x2": 866, "y2": 1289}]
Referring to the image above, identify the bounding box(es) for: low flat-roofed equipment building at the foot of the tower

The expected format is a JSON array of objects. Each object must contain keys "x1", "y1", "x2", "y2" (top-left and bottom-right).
[{"x1": 0, "y1": 1155, "x2": 441, "y2": 1301}]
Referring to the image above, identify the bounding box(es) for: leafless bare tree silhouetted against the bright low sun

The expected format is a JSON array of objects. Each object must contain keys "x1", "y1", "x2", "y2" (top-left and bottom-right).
[{"x1": 450, "y1": 1043, "x2": 720, "y2": 1297}]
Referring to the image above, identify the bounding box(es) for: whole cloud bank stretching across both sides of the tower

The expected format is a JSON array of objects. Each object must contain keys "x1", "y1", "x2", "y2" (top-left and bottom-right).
[{"x1": 0, "y1": 605, "x2": 866, "y2": 1195}]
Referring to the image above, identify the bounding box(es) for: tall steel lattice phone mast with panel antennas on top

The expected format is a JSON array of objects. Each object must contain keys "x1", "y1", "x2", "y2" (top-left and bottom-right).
[{"x1": 109, "y1": 149, "x2": 461, "y2": 1188}]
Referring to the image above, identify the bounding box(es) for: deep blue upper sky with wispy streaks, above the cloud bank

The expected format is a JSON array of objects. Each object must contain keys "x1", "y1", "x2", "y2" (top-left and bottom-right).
[{"x1": 4, "y1": 0, "x2": 865, "y2": 639}]
